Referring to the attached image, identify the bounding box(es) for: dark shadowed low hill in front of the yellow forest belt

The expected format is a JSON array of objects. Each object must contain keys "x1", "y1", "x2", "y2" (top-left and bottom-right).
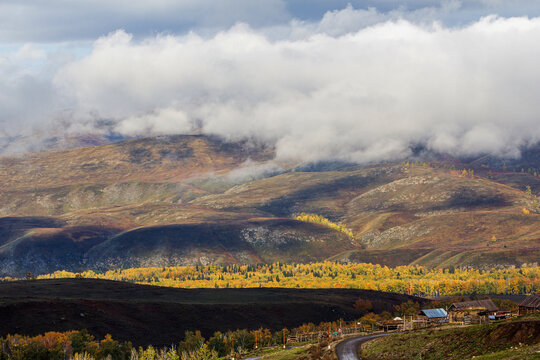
[{"x1": 0, "y1": 279, "x2": 427, "y2": 346}]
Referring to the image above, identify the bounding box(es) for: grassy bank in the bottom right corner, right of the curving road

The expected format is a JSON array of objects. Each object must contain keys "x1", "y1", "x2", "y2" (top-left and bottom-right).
[{"x1": 361, "y1": 316, "x2": 540, "y2": 360}]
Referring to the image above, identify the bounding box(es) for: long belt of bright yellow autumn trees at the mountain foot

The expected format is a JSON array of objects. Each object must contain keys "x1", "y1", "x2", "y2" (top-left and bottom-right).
[{"x1": 26, "y1": 261, "x2": 540, "y2": 296}]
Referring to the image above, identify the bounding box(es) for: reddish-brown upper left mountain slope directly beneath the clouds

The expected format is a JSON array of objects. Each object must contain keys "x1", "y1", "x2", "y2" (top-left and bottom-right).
[{"x1": 0, "y1": 136, "x2": 272, "y2": 190}]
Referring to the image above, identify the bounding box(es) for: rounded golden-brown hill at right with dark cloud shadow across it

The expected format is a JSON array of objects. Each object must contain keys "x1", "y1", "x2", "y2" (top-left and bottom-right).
[{"x1": 340, "y1": 168, "x2": 540, "y2": 267}]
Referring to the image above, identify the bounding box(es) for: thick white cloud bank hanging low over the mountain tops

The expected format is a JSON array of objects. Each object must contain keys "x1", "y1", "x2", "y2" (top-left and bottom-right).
[{"x1": 0, "y1": 1, "x2": 540, "y2": 163}]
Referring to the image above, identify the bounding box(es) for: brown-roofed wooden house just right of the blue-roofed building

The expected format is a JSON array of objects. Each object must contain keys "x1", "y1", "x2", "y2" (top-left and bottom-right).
[{"x1": 448, "y1": 299, "x2": 499, "y2": 324}]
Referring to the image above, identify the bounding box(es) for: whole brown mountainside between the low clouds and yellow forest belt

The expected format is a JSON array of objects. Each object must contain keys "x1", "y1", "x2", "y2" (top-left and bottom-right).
[{"x1": 0, "y1": 136, "x2": 540, "y2": 276}]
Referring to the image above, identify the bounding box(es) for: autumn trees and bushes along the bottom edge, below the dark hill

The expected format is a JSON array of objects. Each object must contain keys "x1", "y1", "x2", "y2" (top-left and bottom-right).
[{"x1": 0, "y1": 316, "x2": 371, "y2": 360}]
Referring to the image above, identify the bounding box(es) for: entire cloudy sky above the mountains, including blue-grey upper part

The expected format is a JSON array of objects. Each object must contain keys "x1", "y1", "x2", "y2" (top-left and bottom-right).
[{"x1": 0, "y1": 0, "x2": 540, "y2": 163}]
